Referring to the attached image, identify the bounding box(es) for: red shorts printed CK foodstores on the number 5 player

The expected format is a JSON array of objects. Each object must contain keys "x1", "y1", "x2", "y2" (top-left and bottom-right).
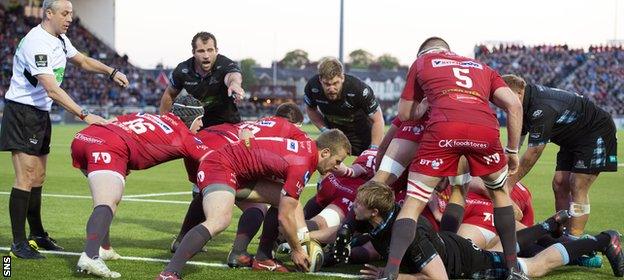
[{"x1": 410, "y1": 122, "x2": 507, "y2": 177}]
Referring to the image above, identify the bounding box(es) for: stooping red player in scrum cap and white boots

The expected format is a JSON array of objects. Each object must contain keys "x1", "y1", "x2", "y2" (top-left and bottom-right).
[{"x1": 71, "y1": 95, "x2": 209, "y2": 278}]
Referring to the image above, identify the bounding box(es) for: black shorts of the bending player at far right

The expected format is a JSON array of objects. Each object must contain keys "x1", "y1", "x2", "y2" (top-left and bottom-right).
[{"x1": 556, "y1": 120, "x2": 617, "y2": 174}]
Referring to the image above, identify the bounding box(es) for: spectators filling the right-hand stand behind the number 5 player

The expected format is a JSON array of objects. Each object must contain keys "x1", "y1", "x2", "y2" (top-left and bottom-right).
[{"x1": 475, "y1": 44, "x2": 624, "y2": 115}]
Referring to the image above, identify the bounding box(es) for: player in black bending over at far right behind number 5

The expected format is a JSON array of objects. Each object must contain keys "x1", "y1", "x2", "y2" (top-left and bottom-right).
[{"x1": 503, "y1": 75, "x2": 618, "y2": 237}]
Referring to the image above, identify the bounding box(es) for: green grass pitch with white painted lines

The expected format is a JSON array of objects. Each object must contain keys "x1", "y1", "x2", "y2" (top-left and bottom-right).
[{"x1": 0, "y1": 125, "x2": 624, "y2": 279}]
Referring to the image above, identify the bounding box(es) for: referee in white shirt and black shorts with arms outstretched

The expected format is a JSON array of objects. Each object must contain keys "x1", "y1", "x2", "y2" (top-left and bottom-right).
[{"x1": 0, "y1": 0, "x2": 128, "y2": 259}]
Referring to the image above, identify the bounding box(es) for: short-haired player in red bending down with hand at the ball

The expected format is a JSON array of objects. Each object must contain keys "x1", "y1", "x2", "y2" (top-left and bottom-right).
[{"x1": 156, "y1": 129, "x2": 351, "y2": 280}]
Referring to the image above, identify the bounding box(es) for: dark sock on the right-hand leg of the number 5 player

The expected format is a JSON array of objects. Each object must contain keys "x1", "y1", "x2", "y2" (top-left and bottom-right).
[{"x1": 494, "y1": 205, "x2": 518, "y2": 268}]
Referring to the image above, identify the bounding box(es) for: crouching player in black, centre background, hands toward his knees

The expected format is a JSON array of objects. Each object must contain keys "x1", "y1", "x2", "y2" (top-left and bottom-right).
[{"x1": 304, "y1": 58, "x2": 384, "y2": 156}]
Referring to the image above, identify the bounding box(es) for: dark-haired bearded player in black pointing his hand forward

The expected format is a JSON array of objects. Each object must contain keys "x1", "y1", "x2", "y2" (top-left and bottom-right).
[{"x1": 160, "y1": 32, "x2": 245, "y2": 128}]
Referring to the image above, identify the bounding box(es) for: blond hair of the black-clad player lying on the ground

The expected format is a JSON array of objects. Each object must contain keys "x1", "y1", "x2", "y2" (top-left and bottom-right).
[{"x1": 356, "y1": 181, "x2": 394, "y2": 215}]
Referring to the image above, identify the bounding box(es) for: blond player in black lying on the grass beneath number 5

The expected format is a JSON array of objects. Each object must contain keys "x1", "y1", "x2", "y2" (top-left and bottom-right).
[{"x1": 326, "y1": 182, "x2": 624, "y2": 279}]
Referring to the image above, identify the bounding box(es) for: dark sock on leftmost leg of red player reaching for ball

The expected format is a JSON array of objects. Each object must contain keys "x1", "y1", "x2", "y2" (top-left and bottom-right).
[{"x1": 165, "y1": 224, "x2": 212, "y2": 274}]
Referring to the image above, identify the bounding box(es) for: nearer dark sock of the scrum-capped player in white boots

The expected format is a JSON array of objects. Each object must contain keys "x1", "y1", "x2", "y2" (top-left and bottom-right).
[{"x1": 85, "y1": 205, "x2": 113, "y2": 259}]
